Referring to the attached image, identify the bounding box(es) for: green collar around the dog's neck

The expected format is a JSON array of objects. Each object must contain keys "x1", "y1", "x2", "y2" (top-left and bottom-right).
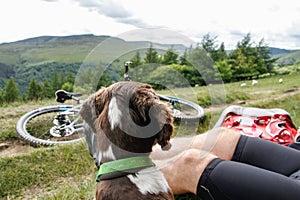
[{"x1": 96, "y1": 156, "x2": 155, "y2": 182}]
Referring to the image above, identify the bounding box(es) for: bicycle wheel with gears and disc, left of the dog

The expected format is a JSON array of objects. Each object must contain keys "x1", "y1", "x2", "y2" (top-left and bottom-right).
[{"x1": 16, "y1": 105, "x2": 84, "y2": 146}]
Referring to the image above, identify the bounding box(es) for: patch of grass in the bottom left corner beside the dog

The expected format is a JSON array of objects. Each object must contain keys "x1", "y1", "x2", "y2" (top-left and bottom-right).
[{"x1": 0, "y1": 143, "x2": 96, "y2": 199}]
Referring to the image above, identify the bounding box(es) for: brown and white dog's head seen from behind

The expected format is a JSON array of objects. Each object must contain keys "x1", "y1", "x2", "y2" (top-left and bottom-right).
[{"x1": 80, "y1": 82, "x2": 173, "y2": 153}]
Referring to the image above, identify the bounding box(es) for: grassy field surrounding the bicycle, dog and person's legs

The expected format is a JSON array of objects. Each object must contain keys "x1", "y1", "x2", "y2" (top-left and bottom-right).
[{"x1": 0, "y1": 75, "x2": 300, "y2": 200}]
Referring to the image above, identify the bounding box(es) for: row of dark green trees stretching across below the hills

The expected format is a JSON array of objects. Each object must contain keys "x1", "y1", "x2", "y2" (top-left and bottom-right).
[{"x1": 0, "y1": 34, "x2": 276, "y2": 104}]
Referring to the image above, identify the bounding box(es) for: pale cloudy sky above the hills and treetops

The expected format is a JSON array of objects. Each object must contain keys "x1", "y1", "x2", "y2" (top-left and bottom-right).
[{"x1": 0, "y1": 0, "x2": 300, "y2": 49}]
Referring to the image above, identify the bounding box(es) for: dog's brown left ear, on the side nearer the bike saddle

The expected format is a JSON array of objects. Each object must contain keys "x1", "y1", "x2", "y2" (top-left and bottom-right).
[{"x1": 79, "y1": 87, "x2": 108, "y2": 133}]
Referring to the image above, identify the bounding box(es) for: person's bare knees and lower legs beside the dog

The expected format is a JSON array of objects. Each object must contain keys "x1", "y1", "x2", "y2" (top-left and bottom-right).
[{"x1": 151, "y1": 128, "x2": 240, "y2": 194}]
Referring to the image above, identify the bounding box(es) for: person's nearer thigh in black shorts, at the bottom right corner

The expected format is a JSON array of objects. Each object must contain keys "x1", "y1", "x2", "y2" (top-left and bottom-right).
[{"x1": 197, "y1": 158, "x2": 300, "y2": 200}]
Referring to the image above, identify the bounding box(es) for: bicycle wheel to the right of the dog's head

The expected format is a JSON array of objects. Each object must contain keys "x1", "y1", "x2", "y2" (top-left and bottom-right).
[{"x1": 157, "y1": 94, "x2": 205, "y2": 120}]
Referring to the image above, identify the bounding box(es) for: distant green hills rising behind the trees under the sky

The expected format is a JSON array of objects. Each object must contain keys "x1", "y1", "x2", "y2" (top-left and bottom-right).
[{"x1": 0, "y1": 34, "x2": 300, "y2": 92}]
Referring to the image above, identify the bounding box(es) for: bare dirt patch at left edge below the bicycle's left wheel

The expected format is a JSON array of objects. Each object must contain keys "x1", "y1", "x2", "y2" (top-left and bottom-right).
[{"x1": 0, "y1": 142, "x2": 34, "y2": 157}]
